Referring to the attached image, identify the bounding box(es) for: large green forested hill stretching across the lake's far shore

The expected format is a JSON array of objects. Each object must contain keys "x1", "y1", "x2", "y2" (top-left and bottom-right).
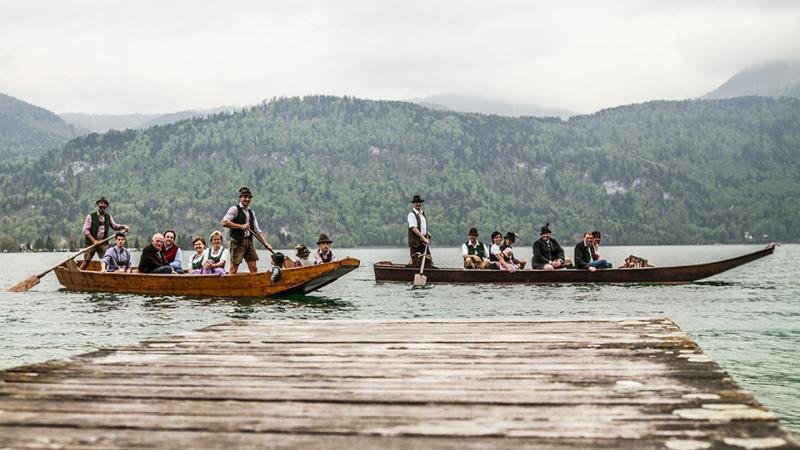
[{"x1": 0, "y1": 97, "x2": 800, "y2": 250}]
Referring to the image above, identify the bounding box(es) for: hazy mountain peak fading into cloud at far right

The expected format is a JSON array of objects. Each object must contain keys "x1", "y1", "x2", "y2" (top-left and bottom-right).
[{"x1": 703, "y1": 63, "x2": 800, "y2": 99}]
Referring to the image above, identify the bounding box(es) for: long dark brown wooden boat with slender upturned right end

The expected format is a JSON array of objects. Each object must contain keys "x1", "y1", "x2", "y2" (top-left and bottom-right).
[{"x1": 373, "y1": 244, "x2": 775, "y2": 284}]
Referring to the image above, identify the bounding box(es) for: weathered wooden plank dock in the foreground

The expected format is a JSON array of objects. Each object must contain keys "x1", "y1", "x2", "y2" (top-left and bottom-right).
[{"x1": 0, "y1": 319, "x2": 800, "y2": 450}]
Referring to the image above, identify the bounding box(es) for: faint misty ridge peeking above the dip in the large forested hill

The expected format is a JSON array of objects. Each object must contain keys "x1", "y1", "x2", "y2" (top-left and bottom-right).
[{"x1": 411, "y1": 94, "x2": 577, "y2": 119}]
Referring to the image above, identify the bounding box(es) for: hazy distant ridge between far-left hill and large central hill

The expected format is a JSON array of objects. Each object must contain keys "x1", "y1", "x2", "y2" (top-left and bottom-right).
[{"x1": 60, "y1": 106, "x2": 235, "y2": 133}]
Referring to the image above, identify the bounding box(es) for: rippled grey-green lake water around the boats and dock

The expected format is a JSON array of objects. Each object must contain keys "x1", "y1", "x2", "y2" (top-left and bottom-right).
[{"x1": 0, "y1": 245, "x2": 800, "y2": 433}]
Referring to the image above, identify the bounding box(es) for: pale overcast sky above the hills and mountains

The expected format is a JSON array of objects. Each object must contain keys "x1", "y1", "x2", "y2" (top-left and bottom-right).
[{"x1": 0, "y1": 0, "x2": 800, "y2": 113}]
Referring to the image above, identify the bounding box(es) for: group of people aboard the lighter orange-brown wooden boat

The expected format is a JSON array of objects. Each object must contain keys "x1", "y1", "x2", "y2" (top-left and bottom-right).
[{"x1": 79, "y1": 187, "x2": 337, "y2": 279}]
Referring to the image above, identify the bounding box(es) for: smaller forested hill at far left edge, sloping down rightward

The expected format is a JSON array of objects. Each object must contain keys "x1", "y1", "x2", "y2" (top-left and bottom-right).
[{"x1": 0, "y1": 94, "x2": 79, "y2": 159}]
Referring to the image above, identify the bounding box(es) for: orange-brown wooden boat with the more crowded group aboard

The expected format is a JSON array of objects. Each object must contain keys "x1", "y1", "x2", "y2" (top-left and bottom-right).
[{"x1": 55, "y1": 258, "x2": 360, "y2": 297}]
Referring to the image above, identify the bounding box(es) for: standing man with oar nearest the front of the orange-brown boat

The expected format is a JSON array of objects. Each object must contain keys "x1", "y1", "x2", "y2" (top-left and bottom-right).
[{"x1": 222, "y1": 186, "x2": 272, "y2": 274}]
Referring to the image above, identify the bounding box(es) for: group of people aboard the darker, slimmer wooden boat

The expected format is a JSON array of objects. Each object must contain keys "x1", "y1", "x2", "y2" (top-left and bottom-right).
[{"x1": 408, "y1": 195, "x2": 613, "y2": 272}]
